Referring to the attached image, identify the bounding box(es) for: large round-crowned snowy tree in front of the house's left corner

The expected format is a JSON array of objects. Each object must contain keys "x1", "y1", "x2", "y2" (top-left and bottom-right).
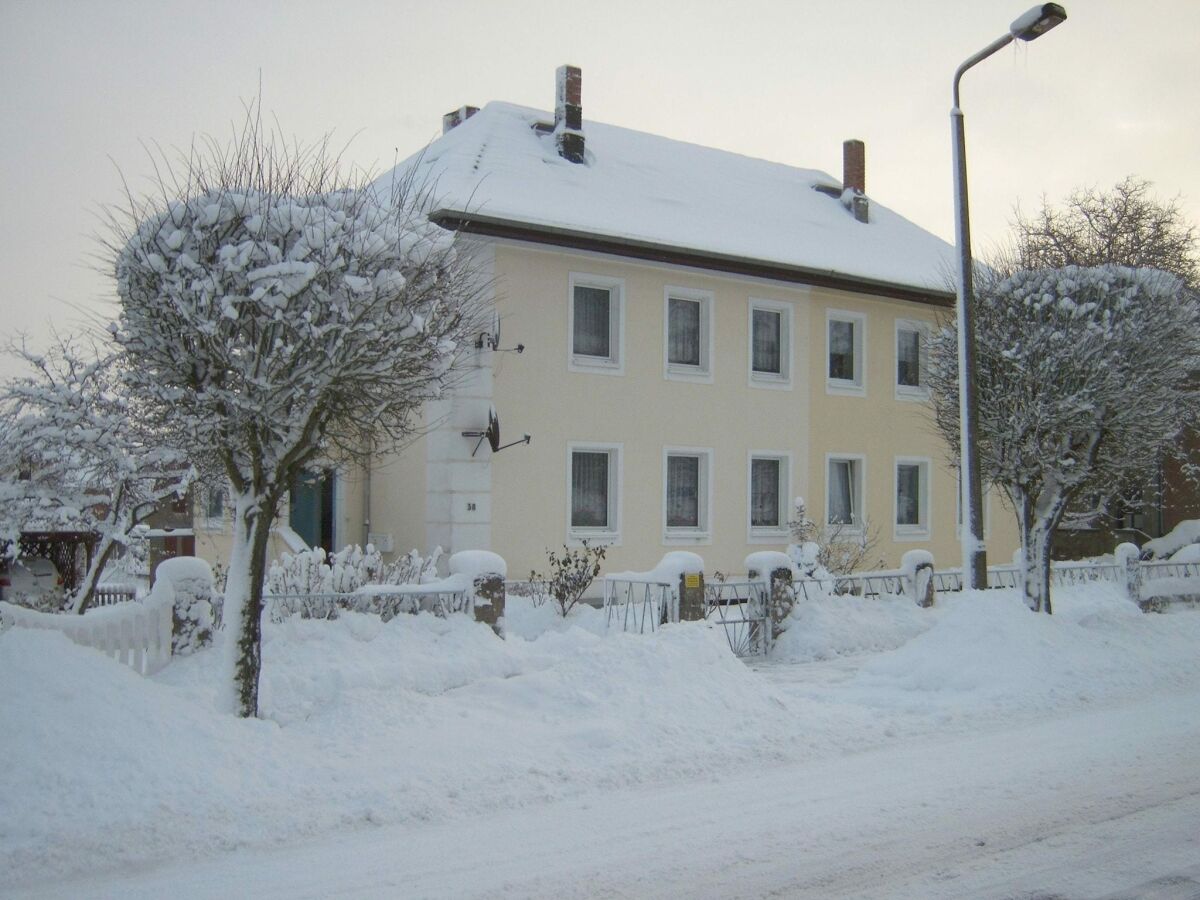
[{"x1": 110, "y1": 116, "x2": 481, "y2": 716}]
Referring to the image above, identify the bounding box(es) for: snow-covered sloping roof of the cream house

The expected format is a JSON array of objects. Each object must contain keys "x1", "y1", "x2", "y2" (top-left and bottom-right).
[{"x1": 377, "y1": 102, "x2": 955, "y2": 300}]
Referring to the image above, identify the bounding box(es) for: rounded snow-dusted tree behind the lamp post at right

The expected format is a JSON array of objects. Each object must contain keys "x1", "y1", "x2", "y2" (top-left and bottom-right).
[{"x1": 930, "y1": 265, "x2": 1200, "y2": 612}]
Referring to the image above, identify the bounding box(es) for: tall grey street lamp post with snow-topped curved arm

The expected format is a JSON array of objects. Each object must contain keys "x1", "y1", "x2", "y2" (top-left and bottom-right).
[{"x1": 950, "y1": 4, "x2": 1067, "y2": 589}]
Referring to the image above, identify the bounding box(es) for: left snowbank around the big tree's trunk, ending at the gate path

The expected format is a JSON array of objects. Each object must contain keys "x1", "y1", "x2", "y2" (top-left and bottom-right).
[{"x1": 0, "y1": 613, "x2": 786, "y2": 882}]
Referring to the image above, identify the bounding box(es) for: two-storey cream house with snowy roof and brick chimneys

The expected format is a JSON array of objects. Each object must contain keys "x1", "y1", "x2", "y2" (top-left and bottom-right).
[{"x1": 197, "y1": 67, "x2": 1018, "y2": 577}]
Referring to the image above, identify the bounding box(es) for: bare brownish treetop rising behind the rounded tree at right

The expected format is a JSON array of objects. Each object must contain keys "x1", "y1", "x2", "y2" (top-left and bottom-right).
[{"x1": 1013, "y1": 175, "x2": 1200, "y2": 288}]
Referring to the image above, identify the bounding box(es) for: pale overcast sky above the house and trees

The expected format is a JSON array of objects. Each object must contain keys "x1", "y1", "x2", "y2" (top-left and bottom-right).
[{"x1": 0, "y1": 0, "x2": 1200, "y2": 374}]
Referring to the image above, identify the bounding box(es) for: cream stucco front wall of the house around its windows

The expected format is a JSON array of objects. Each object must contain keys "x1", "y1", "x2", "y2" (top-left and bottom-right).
[{"x1": 480, "y1": 244, "x2": 1015, "y2": 574}]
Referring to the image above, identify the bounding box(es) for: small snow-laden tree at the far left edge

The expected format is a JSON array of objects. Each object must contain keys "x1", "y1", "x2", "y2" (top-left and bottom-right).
[{"x1": 0, "y1": 337, "x2": 192, "y2": 613}]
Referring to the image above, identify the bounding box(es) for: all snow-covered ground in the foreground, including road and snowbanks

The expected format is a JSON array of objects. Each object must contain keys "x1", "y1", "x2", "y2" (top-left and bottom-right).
[{"x1": 0, "y1": 584, "x2": 1200, "y2": 896}]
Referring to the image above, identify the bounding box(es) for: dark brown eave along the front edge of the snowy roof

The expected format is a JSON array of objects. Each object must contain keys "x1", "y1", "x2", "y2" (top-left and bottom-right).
[{"x1": 430, "y1": 209, "x2": 954, "y2": 307}]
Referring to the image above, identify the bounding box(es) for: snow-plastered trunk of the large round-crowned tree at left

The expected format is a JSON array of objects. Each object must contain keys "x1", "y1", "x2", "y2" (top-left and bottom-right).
[{"x1": 222, "y1": 494, "x2": 272, "y2": 718}]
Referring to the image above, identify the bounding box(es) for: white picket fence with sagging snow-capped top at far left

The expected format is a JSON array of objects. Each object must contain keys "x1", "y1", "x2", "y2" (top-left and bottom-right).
[{"x1": 0, "y1": 580, "x2": 175, "y2": 674}]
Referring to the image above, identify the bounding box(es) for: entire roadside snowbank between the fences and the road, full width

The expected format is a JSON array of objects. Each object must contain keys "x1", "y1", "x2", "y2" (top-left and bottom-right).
[{"x1": 7, "y1": 584, "x2": 1200, "y2": 884}]
